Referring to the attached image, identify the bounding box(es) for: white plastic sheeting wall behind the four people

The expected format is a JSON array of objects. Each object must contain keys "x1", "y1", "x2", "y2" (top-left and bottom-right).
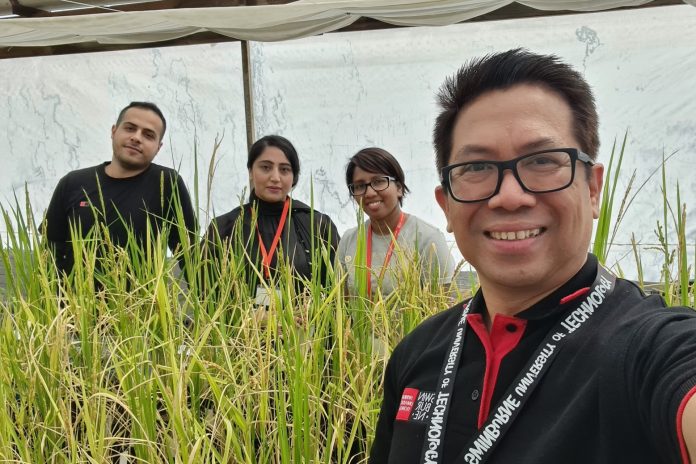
[{"x1": 0, "y1": 5, "x2": 696, "y2": 280}]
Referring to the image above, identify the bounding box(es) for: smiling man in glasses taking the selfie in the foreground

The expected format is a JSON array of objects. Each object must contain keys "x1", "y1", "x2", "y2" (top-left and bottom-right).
[{"x1": 370, "y1": 49, "x2": 696, "y2": 464}]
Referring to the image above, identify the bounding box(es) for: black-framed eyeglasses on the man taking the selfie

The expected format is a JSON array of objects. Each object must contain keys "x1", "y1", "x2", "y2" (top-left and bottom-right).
[{"x1": 440, "y1": 148, "x2": 595, "y2": 203}]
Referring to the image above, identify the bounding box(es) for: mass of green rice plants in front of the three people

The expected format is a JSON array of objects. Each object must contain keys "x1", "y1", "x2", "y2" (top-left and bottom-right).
[{"x1": 0, "y1": 189, "x2": 462, "y2": 463}]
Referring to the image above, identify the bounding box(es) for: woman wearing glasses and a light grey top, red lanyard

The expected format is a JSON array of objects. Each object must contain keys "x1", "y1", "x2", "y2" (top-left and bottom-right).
[{"x1": 337, "y1": 148, "x2": 454, "y2": 295}]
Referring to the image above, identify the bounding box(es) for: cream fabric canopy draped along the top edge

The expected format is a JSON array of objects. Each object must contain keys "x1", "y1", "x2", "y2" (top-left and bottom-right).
[{"x1": 0, "y1": 0, "x2": 696, "y2": 47}]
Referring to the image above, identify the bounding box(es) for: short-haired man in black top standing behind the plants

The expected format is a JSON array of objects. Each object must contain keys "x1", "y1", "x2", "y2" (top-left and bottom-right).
[{"x1": 44, "y1": 102, "x2": 197, "y2": 273}]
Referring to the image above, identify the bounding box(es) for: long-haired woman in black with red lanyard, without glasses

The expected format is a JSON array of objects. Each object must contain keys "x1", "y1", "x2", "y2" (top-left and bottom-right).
[{"x1": 205, "y1": 135, "x2": 339, "y2": 300}]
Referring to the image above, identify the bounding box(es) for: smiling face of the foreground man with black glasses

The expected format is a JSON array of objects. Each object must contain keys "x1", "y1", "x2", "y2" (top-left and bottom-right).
[{"x1": 436, "y1": 84, "x2": 603, "y2": 294}]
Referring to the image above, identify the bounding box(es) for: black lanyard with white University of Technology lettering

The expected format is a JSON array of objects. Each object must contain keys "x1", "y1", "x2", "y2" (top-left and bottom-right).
[{"x1": 420, "y1": 264, "x2": 616, "y2": 464}]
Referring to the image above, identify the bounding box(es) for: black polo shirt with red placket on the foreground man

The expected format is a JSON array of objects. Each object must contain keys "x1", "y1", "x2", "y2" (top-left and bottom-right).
[{"x1": 370, "y1": 255, "x2": 696, "y2": 464}]
